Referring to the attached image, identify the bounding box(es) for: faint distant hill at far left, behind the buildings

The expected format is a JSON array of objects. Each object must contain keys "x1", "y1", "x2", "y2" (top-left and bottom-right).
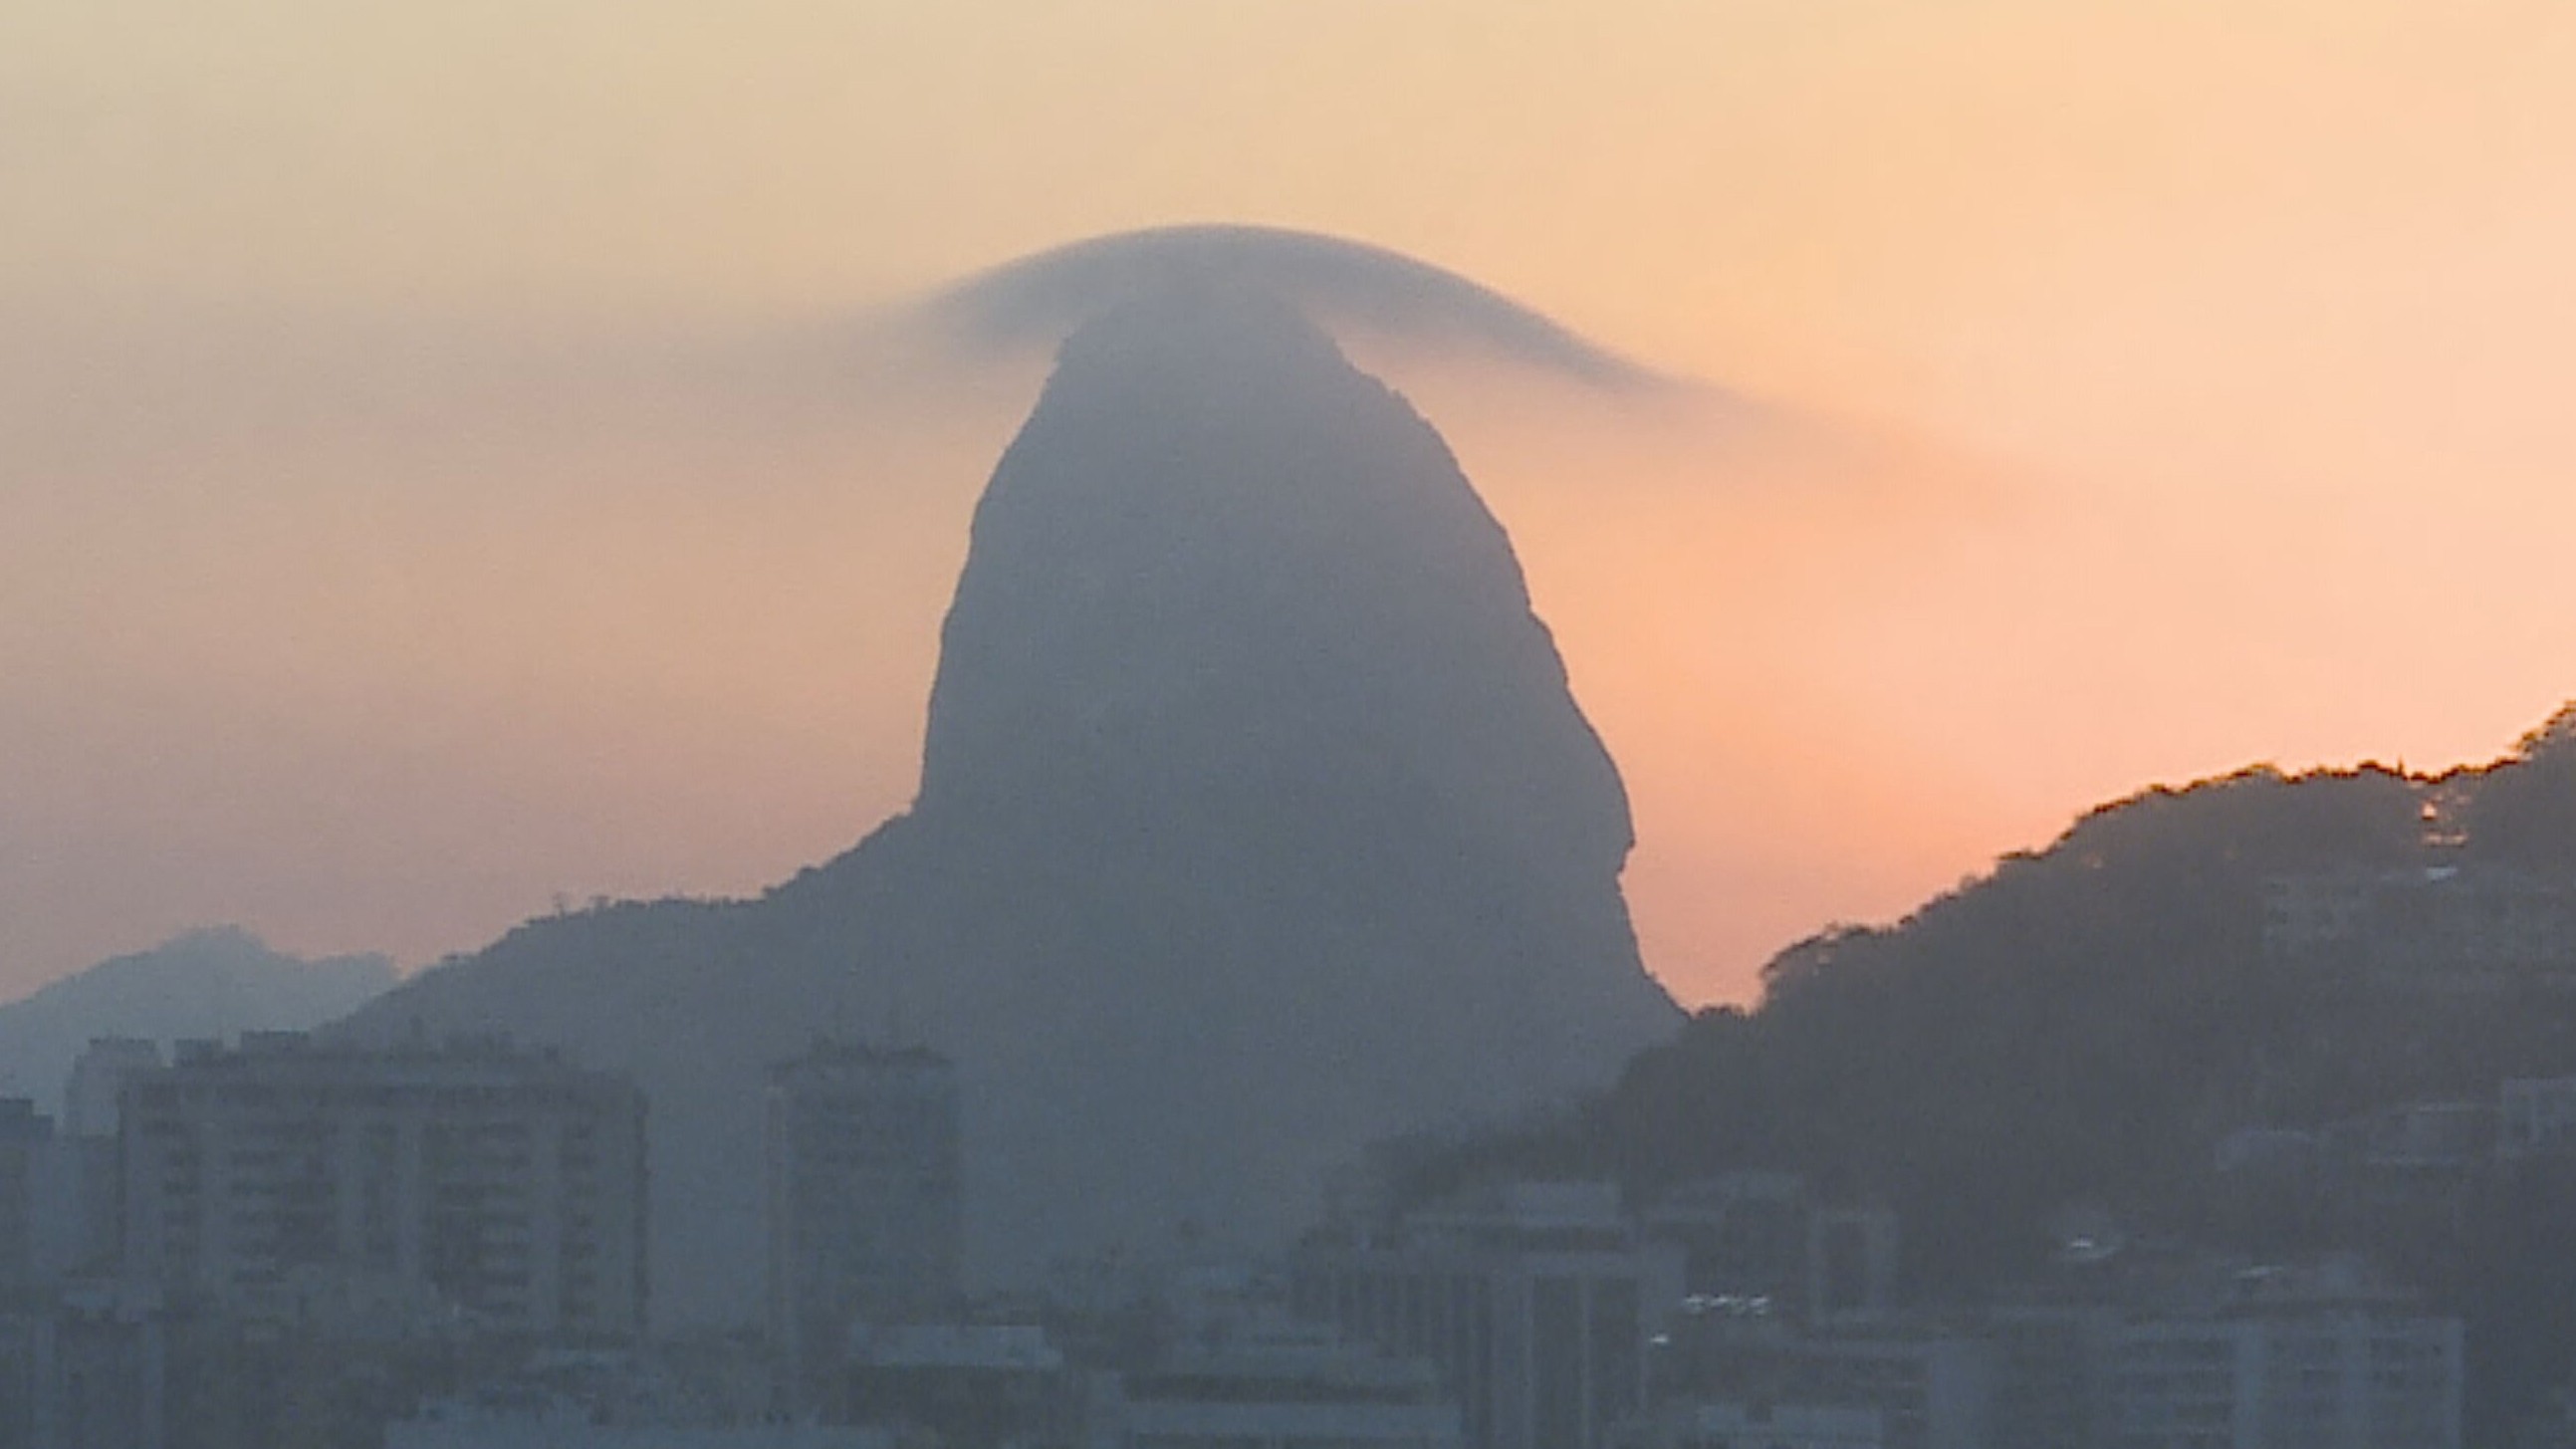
[{"x1": 0, "y1": 925, "x2": 394, "y2": 1111}]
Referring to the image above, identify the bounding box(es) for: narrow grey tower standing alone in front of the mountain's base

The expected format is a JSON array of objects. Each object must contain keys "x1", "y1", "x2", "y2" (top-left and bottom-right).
[{"x1": 768, "y1": 1042, "x2": 964, "y2": 1402}]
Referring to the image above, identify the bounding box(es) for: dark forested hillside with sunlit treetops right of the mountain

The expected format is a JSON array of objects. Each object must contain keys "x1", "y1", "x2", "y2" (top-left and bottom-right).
[{"x1": 1409, "y1": 709, "x2": 2576, "y2": 1295}]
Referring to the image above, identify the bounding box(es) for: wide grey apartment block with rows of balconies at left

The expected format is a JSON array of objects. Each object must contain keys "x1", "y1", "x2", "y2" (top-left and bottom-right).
[{"x1": 118, "y1": 1034, "x2": 646, "y2": 1340}]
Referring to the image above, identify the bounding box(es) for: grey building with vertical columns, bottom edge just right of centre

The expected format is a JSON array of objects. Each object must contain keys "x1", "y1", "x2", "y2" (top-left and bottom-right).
[{"x1": 1290, "y1": 1183, "x2": 1685, "y2": 1449}]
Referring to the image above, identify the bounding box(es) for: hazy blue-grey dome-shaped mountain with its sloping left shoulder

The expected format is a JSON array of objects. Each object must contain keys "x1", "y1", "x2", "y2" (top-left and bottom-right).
[{"x1": 337, "y1": 292, "x2": 1680, "y2": 1321}]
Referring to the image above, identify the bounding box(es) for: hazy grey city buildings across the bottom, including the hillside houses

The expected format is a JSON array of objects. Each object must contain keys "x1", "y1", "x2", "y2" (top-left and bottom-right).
[{"x1": 25, "y1": 841, "x2": 2576, "y2": 1449}]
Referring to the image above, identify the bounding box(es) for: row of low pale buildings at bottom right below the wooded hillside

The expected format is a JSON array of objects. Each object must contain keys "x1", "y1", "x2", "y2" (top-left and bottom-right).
[{"x1": 1633, "y1": 1264, "x2": 2462, "y2": 1449}]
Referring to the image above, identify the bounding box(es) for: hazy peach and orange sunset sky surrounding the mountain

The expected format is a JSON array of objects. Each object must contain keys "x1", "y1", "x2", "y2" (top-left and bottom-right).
[{"x1": 0, "y1": 0, "x2": 2576, "y2": 1001}]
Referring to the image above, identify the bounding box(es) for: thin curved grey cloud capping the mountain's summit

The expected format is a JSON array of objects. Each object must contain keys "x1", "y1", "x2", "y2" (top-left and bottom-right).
[{"x1": 925, "y1": 224, "x2": 1685, "y2": 392}]
